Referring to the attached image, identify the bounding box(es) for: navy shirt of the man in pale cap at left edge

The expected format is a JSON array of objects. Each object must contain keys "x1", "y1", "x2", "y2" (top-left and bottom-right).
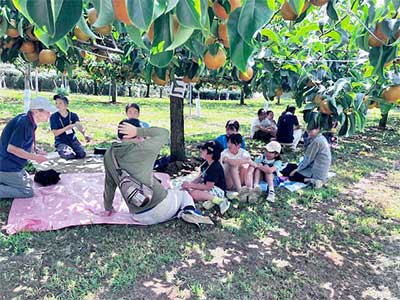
[{"x1": 0, "y1": 112, "x2": 37, "y2": 172}]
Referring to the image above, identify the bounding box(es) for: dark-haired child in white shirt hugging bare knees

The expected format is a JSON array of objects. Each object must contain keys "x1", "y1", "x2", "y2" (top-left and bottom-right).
[{"x1": 221, "y1": 134, "x2": 252, "y2": 201}]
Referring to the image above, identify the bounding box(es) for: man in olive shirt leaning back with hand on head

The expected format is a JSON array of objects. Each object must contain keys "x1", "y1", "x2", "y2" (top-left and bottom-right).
[{"x1": 104, "y1": 119, "x2": 213, "y2": 225}]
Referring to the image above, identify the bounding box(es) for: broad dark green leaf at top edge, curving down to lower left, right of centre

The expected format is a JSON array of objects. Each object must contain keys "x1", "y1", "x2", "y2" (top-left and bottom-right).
[{"x1": 237, "y1": 0, "x2": 274, "y2": 43}]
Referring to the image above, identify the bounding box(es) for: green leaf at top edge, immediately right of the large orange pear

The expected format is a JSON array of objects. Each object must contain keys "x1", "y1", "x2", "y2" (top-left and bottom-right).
[{"x1": 126, "y1": 0, "x2": 155, "y2": 31}]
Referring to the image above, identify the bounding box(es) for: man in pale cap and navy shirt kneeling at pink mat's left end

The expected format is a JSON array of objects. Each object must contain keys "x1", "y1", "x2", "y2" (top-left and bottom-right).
[{"x1": 0, "y1": 97, "x2": 57, "y2": 199}]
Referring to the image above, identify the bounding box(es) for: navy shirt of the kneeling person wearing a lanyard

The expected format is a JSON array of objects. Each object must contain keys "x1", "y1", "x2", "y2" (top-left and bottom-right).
[{"x1": 50, "y1": 111, "x2": 79, "y2": 147}]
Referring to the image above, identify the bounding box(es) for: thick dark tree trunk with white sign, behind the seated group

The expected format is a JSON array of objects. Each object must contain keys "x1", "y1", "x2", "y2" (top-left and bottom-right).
[{"x1": 169, "y1": 78, "x2": 186, "y2": 161}]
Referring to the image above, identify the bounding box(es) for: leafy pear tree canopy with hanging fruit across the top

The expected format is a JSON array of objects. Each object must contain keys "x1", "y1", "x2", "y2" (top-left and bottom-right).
[{"x1": 0, "y1": 0, "x2": 400, "y2": 135}]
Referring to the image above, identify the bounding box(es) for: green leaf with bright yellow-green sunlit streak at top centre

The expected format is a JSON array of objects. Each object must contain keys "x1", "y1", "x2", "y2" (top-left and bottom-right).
[{"x1": 176, "y1": 0, "x2": 208, "y2": 29}]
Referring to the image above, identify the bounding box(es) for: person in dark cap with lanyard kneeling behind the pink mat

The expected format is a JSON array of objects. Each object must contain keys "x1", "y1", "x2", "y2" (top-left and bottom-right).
[{"x1": 50, "y1": 95, "x2": 91, "y2": 159}]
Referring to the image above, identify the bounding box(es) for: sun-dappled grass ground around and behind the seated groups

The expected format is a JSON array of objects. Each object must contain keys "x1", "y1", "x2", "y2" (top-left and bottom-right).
[{"x1": 0, "y1": 90, "x2": 400, "y2": 300}]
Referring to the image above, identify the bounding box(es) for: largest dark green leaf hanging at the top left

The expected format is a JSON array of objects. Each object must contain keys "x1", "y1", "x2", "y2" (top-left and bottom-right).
[{"x1": 26, "y1": 0, "x2": 82, "y2": 44}]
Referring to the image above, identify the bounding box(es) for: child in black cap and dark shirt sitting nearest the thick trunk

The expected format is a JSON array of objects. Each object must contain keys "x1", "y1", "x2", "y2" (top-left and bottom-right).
[{"x1": 182, "y1": 141, "x2": 230, "y2": 215}]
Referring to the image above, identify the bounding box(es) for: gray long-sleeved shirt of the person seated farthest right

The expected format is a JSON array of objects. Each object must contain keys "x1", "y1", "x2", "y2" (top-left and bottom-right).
[{"x1": 297, "y1": 134, "x2": 332, "y2": 181}]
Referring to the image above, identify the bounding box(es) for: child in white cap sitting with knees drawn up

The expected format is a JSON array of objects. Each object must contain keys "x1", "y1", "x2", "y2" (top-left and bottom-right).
[{"x1": 254, "y1": 141, "x2": 282, "y2": 202}]
